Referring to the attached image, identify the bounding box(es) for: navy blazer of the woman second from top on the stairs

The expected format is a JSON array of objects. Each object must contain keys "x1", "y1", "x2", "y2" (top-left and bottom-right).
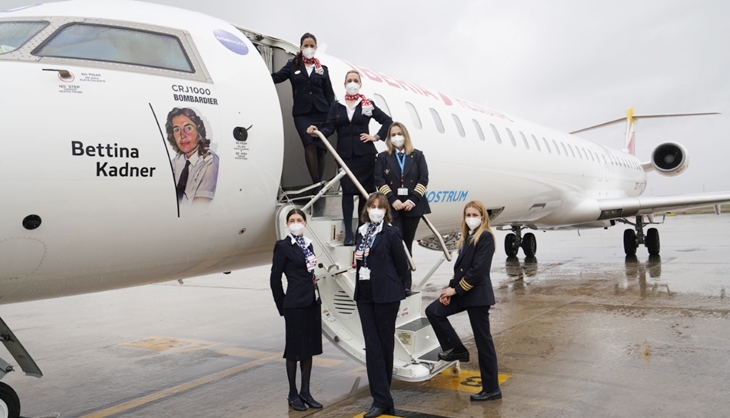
[{"x1": 318, "y1": 100, "x2": 393, "y2": 158}]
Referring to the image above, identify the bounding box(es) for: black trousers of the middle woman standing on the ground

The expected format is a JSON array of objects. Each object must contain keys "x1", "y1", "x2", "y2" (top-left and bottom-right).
[{"x1": 357, "y1": 302, "x2": 400, "y2": 408}]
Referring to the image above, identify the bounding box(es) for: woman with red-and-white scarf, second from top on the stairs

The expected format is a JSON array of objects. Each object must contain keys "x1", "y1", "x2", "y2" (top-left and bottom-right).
[{"x1": 307, "y1": 70, "x2": 393, "y2": 245}]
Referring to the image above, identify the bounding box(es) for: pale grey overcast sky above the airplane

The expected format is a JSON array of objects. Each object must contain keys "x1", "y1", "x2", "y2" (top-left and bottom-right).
[{"x1": 7, "y1": 0, "x2": 730, "y2": 196}]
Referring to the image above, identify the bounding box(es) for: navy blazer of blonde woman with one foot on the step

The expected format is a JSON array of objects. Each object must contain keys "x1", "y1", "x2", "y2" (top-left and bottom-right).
[{"x1": 449, "y1": 231, "x2": 494, "y2": 308}]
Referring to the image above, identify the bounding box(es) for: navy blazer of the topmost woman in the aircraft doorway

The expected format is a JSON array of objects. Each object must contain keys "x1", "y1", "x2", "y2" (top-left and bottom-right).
[{"x1": 271, "y1": 60, "x2": 335, "y2": 116}]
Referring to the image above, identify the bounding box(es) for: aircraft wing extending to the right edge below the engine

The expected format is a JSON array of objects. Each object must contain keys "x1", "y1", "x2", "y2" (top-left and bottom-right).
[{"x1": 598, "y1": 192, "x2": 730, "y2": 219}]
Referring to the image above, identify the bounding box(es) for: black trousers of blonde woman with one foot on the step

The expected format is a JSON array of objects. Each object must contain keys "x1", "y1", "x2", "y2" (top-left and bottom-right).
[{"x1": 426, "y1": 295, "x2": 499, "y2": 392}]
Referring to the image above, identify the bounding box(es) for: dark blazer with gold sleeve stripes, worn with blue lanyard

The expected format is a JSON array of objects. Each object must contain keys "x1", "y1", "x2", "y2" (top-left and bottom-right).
[{"x1": 375, "y1": 149, "x2": 431, "y2": 218}]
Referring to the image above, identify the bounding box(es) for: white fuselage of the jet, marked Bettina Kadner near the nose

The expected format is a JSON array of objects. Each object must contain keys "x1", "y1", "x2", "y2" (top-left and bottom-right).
[{"x1": 0, "y1": 2, "x2": 646, "y2": 303}]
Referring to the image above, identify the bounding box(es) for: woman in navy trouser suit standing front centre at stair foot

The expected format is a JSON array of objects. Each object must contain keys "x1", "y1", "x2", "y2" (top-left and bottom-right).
[{"x1": 354, "y1": 193, "x2": 411, "y2": 418}]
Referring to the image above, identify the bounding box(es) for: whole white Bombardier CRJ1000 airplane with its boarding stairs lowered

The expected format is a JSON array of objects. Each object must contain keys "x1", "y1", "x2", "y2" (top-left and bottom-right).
[{"x1": 0, "y1": 0, "x2": 730, "y2": 417}]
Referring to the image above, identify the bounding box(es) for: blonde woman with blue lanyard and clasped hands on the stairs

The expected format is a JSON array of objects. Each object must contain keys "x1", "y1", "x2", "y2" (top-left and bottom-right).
[{"x1": 375, "y1": 122, "x2": 431, "y2": 258}]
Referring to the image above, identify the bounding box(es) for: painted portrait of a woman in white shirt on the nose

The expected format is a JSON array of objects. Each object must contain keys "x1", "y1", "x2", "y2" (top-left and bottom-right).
[{"x1": 165, "y1": 107, "x2": 218, "y2": 205}]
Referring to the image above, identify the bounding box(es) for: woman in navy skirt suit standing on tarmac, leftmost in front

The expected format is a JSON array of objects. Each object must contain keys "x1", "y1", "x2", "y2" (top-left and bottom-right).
[{"x1": 270, "y1": 209, "x2": 322, "y2": 411}]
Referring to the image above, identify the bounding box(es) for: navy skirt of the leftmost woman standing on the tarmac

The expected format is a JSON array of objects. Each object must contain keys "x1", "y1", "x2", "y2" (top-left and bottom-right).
[{"x1": 284, "y1": 302, "x2": 322, "y2": 361}]
